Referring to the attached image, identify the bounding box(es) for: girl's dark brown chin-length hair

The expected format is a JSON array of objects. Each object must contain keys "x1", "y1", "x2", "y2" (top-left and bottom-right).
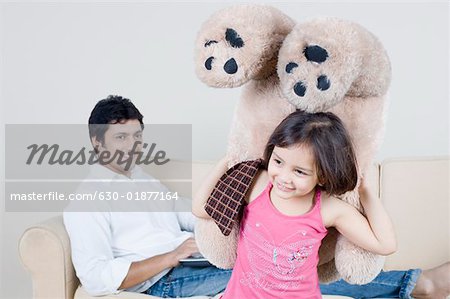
[{"x1": 264, "y1": 110, "x2": 358, "y2": 195}]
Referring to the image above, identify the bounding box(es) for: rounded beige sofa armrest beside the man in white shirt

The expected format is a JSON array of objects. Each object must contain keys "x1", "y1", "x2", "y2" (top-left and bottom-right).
[{"x1": 19, "y1": 216, "x2": 80, "y2": 299}]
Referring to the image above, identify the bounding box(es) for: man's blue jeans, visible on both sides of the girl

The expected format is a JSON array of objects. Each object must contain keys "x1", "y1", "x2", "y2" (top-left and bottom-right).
[{"x1": 145, "y1": 266, "x2": 422, "y2": 299}]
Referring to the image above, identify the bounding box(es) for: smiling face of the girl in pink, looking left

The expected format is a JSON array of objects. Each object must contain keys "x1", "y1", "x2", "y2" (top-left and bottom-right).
[{"x1": 267, "y1": 145, "x2": 319, "y2": 200}]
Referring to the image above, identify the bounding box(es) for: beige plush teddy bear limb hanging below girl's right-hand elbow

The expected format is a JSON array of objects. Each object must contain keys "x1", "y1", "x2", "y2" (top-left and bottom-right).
[{"x1": 335, "y1": 235, "x2": 385, "y2": 284}]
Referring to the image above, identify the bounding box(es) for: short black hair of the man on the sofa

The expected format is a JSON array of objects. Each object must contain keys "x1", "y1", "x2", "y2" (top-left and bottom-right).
[{"x1": 88, "y1": 95, "x2": 144, "y2": 147}]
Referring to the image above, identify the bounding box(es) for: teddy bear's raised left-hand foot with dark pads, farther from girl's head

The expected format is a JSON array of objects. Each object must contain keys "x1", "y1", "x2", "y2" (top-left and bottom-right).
[{"x1": 195, "y1": 5, "x2": 294, "y2": 87}]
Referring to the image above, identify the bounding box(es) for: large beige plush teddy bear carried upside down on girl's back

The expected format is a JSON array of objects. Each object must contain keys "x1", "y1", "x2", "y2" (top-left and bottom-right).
[{"x1": 196, "y1": 5, "x2": 391, "y2": 284}]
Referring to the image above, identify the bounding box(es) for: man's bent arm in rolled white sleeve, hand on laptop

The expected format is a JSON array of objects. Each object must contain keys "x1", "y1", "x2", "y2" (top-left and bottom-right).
[{"x1": 64, "y1": 212, "x2": 198, "y2": 296}]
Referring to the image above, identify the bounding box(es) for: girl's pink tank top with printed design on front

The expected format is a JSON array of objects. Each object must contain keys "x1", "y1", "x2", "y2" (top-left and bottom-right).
[{"x1": 222, "y1": 183, "x2": 327, "y2": 299}]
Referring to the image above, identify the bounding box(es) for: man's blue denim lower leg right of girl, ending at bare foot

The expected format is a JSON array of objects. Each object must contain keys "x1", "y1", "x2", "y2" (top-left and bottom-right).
[{"x1": 320, "y1": 269, "x2": 422, "y2": 299}]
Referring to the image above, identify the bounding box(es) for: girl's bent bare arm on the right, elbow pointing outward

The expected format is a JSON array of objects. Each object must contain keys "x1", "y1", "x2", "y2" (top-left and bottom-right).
[{"x1": 327, "y1": 182, "x2": 397, "y2": 255}]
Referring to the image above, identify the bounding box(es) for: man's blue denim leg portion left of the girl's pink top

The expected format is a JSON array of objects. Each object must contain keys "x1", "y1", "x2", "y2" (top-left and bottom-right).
[{"x1": 146, "y1": 266, "x2": 232, "y2": 298}]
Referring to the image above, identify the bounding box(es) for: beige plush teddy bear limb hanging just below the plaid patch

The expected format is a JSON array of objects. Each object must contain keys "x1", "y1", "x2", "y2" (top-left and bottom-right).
[{"x1": 195, "y1": 219, "x2": 239, "y2": 269}]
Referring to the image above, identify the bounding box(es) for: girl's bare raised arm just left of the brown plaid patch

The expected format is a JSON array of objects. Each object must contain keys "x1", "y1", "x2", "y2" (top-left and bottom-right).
[{"x1": 192, "y1": 157, "x2": 228, "y2": 219}]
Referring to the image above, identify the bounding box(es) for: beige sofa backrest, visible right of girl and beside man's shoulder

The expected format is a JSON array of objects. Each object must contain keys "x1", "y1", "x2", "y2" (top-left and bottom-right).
[{"x1": 144, "y1": 157, "x2": 450, "y2": 269}]
